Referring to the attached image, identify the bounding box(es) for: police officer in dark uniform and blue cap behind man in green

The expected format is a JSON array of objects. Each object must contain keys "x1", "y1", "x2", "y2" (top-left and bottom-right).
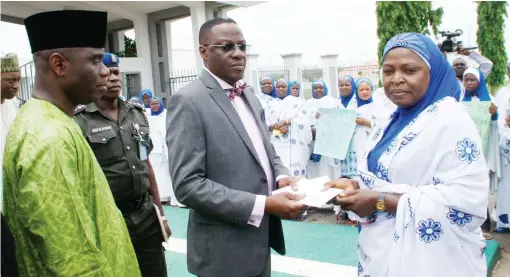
[{"x1": 75, "y1": 53, "x2": 171, "y2": 277}]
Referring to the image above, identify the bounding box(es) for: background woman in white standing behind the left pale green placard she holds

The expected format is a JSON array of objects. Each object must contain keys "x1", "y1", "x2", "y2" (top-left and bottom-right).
[{"x1": 301, "y1": 80, "x2": 338, "y2": 178}]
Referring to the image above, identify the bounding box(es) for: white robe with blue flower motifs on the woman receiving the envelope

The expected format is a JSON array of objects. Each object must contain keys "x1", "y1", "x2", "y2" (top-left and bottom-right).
[{"x1": 352, "y1": 97, "x2": 489, "y2": 277}]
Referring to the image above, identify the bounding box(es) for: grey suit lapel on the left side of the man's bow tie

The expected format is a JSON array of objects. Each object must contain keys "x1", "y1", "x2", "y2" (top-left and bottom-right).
[{"x1": 200, "y1": 70, "x2": 262, "y2": 167}]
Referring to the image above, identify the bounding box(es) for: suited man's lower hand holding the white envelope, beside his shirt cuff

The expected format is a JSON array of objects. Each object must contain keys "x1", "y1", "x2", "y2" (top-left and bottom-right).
[{"x1": 265, "y1": 192, "x2": 306, "y2": 219}]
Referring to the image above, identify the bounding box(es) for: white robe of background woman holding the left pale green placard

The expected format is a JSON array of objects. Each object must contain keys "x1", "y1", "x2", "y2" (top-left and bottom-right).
[{"x1": 301, "y1": 95, "x2": 343, "y2": 179}]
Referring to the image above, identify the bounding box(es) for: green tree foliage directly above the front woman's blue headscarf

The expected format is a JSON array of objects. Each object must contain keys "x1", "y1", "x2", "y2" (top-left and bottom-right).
[{"x1": 376, "y1": 1, "x2": 443, "y2": 61}]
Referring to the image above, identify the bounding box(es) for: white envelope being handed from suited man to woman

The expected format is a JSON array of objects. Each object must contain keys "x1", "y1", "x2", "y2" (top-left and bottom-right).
[{"x1": 273, "y1": 176, "x2": 343, "y2": 208}]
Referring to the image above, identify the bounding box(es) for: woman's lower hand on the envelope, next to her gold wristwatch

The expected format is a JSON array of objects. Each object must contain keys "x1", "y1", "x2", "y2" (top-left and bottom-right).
[{"x1": 335, "y1": 189, "x2": 379, "y2": 217}]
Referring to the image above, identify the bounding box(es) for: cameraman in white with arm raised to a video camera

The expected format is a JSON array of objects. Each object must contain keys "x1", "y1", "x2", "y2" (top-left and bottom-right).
[{"x1": 452, "y1": 47, "x2": 493, "y2": 101}]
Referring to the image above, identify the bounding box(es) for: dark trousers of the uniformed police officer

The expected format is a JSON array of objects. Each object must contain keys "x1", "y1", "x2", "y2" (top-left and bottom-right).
[{"x1": 124, "y1": 211, "x2": 167, "y2": 277}]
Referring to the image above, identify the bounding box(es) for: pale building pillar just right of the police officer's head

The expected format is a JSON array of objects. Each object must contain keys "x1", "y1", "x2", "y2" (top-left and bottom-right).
[{"x1": 133, "y1": 17, "x2": 154, "y2": 92}]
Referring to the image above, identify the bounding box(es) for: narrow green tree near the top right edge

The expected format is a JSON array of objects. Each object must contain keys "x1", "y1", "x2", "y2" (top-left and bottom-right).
[{"x1": 476, "y1": 1, "x2": 508, "y2": 93}]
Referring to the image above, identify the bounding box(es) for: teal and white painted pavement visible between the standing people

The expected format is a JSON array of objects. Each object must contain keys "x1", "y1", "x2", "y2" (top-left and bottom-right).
[{"x1": 165, "y1": 207, "x2": 510, "y2": 277}]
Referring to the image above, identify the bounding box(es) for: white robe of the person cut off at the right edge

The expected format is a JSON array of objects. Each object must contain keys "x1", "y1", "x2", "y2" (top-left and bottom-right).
[{"x1": 496, "y1": 86, "x2": 510, "y2": 228}]
